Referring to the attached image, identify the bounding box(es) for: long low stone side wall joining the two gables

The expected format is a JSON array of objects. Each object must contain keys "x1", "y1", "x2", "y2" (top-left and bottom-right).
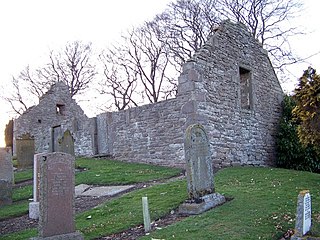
[{"x1": 97, "y1": 96, "x2": 187, "y2": 167}]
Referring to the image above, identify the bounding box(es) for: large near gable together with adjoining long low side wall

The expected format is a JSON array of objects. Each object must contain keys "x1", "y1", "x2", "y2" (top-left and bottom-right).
[{"x1": 97, "y1": 21, "x2": 283, "y2": 167}]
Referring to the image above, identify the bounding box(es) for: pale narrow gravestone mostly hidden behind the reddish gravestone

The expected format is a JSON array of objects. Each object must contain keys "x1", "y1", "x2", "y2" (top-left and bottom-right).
[{"x1": 29, "y1": 153, "x2": 46, "y2": 219}]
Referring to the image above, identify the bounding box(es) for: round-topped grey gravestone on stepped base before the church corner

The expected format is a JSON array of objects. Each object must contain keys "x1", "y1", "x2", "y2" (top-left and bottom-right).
[{"x1": 179, "y1": 124, "x2": 226, "y2": 214}]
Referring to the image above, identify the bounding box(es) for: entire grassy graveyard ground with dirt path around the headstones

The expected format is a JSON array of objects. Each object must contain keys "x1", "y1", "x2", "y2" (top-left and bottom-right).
[{"x1": 0, "y1": 159, "x2": 320, "y2": 239}]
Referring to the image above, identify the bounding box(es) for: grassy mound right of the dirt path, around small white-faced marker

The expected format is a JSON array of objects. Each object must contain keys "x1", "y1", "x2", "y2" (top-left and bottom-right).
[{"x1": 141, "y1": 167, "x2": 320, "y2": 240}]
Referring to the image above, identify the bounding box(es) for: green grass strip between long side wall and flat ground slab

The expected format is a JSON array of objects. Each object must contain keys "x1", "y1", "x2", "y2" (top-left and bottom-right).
[{"x1": 76, "y1": 158, "x2": 181, "y2": 185}]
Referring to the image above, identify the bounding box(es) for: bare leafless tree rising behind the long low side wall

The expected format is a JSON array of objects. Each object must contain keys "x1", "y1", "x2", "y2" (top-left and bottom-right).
[{"x1": 101, "y1": 23, "x2": 176, "y2": 110}]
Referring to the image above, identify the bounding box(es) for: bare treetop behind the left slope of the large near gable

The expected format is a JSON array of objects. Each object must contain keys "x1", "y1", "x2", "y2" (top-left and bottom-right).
[{"x1": 149, "y1": 0, "x2": 219, "y2": 70}]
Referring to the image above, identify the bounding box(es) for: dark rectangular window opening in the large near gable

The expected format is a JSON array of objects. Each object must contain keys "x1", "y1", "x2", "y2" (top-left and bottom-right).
[{"x1": 239, "y1": 67, "x2": 252, "y2": 109}]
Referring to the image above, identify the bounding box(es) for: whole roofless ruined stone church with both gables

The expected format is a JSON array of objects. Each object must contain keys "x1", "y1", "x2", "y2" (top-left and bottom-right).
[{"x1": 14, "y1": 21, "x2": 283, "y2": 167}]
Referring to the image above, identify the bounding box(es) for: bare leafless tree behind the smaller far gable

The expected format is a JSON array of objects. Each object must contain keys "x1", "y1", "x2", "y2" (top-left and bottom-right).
[{"x1": 1, "y1": 41, "x2": 97, "y2": 115}]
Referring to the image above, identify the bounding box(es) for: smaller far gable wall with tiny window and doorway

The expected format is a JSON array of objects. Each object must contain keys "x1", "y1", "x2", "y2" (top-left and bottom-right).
[{"x1": 14, "y1": 82, "x2": 94, "y2": 155}]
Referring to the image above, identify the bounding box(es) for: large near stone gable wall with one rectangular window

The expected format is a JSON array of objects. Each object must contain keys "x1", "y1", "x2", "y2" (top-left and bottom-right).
[{"x1": 179, "y1": 21, "x2": 283, "y2": 166}]
